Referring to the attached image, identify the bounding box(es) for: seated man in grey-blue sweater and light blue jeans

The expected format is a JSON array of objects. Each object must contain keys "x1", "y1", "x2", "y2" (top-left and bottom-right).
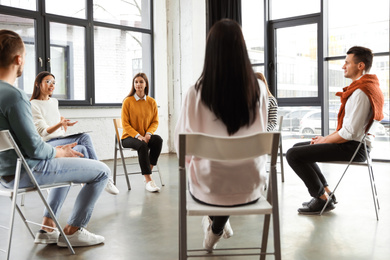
[{"x1": 0, "y1": 30, "x2": 110, "y2": 247}]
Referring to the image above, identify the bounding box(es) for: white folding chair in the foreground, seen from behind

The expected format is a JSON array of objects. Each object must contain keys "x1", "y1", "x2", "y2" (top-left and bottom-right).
[{"x1": 179, "y1": 132, "x2": 281, "y2": 260}]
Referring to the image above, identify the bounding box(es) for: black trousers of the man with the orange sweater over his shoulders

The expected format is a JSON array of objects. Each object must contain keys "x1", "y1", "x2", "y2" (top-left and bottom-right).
[{"x1": 286, "y1": 141, "x2": 369, "y2": 198}]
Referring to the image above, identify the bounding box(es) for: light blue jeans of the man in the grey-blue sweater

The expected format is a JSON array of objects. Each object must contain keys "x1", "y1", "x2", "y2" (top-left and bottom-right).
[{"x1": 2, "y1": 158, "x2": 111, "y2": 227}]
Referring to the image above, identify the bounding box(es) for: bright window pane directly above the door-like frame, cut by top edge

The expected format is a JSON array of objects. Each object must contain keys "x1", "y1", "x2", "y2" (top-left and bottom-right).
[{"x1": 272, "y1": 0, "x2": 320, "y2": 20}]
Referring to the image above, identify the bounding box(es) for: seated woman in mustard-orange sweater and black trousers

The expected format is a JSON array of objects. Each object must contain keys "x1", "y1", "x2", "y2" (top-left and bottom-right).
[{"x1": 122, "y1": 73, "x2": 163, "y2": 192}]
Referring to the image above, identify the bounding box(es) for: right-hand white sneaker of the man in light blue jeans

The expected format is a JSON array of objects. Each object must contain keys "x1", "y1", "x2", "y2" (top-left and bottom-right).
[{"x1": 57, "y1": 228, "x2": 104, "y2": 247}]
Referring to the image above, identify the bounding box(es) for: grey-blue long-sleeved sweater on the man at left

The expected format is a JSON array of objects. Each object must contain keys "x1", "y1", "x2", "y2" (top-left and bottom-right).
[{"x1": 0, "y1": 80, "x2": 56, "y2": 176}]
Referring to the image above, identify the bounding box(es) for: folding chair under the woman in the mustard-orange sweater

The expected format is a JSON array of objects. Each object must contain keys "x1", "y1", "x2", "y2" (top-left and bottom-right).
[{"x1": 113, "y1": 118, "x2": 165, "y2": 190}]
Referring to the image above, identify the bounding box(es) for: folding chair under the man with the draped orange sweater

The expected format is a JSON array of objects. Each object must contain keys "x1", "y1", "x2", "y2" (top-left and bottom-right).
[{"x1": 320, "y1": 120, "x2": 380, "y2": 220}]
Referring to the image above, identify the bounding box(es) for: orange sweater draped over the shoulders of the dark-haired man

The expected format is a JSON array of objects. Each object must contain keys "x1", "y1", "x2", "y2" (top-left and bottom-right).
[{"x1": 336, "y1": 74, "x2": 384, "y2": 131}]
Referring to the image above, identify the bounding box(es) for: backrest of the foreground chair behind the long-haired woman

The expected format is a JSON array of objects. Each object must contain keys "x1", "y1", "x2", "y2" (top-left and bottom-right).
[{"x1": 179, "y1": 132, "x2": 280, "y2": 167}]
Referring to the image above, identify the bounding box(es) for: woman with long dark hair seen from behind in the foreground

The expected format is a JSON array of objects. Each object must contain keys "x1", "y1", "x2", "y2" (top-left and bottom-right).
[{"x1": 175, "y1": 19, "x2": 268, "y2": 252}]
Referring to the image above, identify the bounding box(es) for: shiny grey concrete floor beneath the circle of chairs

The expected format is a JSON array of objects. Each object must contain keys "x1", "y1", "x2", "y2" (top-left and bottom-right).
[{"x1": 0, "y1": 155, "x2": 390, "y2": 260}]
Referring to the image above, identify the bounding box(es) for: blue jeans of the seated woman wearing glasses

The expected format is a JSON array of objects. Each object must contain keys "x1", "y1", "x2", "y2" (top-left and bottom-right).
[{"x1": 46, "y1": 133, "x2": 98, "y2": 160}]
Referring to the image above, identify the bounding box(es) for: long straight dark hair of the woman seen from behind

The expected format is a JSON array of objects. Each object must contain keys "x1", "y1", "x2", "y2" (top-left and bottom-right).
[{"x1": 195, "y1": 19, "x2": 260, "y2": 135}]
